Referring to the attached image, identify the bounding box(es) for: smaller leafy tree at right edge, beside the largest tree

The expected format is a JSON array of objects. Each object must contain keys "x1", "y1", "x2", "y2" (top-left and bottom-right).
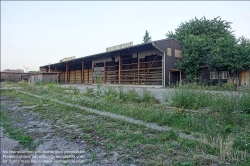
[{"x1": 206, "y1": 35, "x2": 250, "y2": 77}]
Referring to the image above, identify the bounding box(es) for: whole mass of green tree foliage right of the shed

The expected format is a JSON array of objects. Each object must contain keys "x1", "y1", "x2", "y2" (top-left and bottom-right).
[{"x1": 166, "y1": 17, "x2": 250, "y2": 81}]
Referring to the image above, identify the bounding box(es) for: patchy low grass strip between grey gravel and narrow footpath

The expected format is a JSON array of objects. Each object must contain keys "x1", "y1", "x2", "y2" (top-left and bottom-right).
[{"x1": 0, "y1": 90, "x2": 232, "y2": 165}]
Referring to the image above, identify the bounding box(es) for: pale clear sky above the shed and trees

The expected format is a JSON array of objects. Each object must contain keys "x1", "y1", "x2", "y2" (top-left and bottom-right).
[{"x1": 1, "y1": 1, "x2": 250, "y2": 71}]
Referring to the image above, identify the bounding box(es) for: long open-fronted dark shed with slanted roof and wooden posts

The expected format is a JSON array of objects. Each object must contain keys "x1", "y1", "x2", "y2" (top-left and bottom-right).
[{"x1": 40, "y1": 38, "x2": 185, "y2": 86}]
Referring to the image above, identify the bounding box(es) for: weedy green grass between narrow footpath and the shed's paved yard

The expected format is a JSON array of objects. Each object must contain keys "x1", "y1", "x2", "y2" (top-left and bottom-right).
[{"x1": 1, "y1": 81, "x2": 250, "y2": 163}]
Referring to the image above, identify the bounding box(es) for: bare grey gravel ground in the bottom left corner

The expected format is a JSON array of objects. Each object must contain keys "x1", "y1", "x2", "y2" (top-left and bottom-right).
[{"x1": 1, "y1": 96, "x2": 129, "y2": 166}]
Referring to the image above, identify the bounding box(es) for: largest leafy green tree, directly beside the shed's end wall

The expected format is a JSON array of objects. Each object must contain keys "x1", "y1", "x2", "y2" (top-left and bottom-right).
[{"x1": 166, "y1": 17, "x2": 233, "y2": 81}]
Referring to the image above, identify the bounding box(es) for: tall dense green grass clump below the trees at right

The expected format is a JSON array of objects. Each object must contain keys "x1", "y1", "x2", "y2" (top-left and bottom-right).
[{"x1": 171, "y1": 85, "x2": 250, "y2": 114}]
